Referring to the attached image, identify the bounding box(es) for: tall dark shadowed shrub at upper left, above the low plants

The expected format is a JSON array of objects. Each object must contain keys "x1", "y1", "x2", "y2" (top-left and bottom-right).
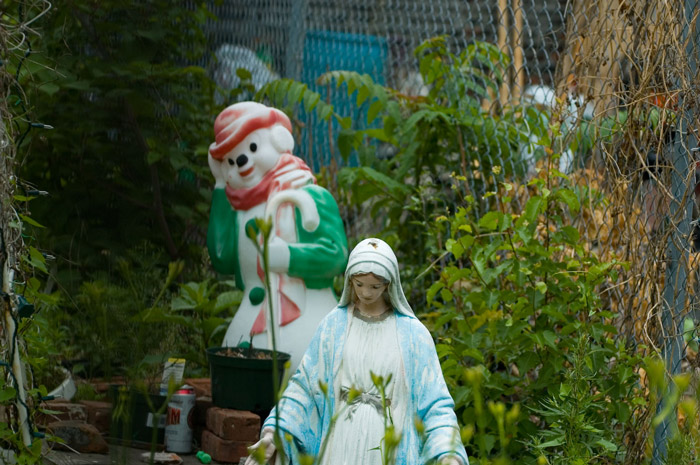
[{"x1": 20, "y1": 0, "x2": 217, "y2": 295}]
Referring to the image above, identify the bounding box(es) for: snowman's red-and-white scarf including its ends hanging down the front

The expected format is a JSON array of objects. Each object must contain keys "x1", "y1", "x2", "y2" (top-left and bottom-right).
[{"x1": 226, "y1": 153, "x2": 316, "y2": 335}]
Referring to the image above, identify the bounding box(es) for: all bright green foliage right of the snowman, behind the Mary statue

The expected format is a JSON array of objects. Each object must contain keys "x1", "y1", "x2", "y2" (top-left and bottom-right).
[{"x1": 258, "y1": 37, "x2": 697, "y2": 465}]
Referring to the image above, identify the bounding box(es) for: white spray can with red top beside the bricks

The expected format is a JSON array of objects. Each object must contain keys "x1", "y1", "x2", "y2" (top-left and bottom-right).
[{"x1": 165, "y1": 384, "x2": 195, "y2": 454}]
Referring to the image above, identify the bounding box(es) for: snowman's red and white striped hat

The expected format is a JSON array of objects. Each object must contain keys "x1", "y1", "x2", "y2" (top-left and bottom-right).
[{"x1": 209, "y1": 102, "x2": 292, "y2": 160}]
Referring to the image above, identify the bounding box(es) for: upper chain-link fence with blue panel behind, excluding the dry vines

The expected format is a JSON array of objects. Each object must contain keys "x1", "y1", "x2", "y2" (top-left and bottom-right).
[{"x1": 208, "y1": 0, "x2": 567, "y2": 169}]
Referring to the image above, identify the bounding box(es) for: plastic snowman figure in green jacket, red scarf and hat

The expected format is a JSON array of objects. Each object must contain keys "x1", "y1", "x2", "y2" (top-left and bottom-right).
[{"x1": 207, "y1": 102, "x2": 348, "y2": 370}]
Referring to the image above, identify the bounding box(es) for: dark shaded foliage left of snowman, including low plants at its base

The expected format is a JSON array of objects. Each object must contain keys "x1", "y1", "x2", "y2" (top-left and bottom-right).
[{"x1": 19, "y1": 0, "x2": 231, "y2": 383}]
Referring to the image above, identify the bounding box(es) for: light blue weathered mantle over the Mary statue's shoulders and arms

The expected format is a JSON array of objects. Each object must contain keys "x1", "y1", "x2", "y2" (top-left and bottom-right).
[{"x1": 263, "y1": 306, "x2": 469, "y2": 465}]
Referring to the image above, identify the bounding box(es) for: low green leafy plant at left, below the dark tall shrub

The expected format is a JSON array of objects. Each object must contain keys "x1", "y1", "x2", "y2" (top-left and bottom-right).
[{"x1": 49, "y1": 243, "x2": 182, "y2": 378}]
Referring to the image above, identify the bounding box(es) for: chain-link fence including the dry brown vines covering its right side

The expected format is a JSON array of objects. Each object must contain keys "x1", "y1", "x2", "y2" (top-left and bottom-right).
[{"x1": 208, "y1": 0, "x2": 700, "y2": 463}]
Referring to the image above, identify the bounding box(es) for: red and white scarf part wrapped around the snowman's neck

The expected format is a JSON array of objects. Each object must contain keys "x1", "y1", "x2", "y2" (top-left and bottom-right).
[{"x1": 226, "y1": 153, "x2": 316, "y2": 210}]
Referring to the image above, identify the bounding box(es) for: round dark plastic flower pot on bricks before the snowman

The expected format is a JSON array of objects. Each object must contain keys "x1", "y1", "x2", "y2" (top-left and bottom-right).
[{"x1": 207, "y1": 347, "x2": 291, "y2": 412}]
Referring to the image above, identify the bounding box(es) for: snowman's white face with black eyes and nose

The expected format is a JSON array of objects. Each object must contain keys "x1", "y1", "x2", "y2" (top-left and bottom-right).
[{"x1": 221, "y1": 129, "x2": 280, "y2": 189}]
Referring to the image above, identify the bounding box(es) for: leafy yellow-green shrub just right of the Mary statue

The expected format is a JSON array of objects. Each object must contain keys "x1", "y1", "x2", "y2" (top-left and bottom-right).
[{"x1": 426, "y1": 172, "x2": 640, "y2": 464}]
